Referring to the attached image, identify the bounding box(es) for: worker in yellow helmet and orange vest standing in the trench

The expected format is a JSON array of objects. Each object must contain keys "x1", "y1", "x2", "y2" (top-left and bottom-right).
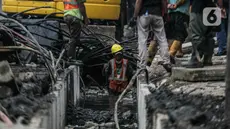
[{"x1": 104, "y1": 44, "x2": 133, "y2": 95}]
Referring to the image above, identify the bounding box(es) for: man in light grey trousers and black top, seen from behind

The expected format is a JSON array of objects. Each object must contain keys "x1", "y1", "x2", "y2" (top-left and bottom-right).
[{"x1": 131, "y1": 0, "x2": 172, "y2": 72}]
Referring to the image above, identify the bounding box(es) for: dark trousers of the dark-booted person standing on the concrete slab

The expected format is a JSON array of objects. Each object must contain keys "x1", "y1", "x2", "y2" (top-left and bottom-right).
[{"x1": 189, "y1": 13, "x2": 214, "y2": 63}]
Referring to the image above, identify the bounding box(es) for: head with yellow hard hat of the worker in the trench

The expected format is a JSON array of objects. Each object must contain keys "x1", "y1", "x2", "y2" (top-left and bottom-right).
[{"x1": 111, "y1": 44, "x2": 123, "y2": 61}]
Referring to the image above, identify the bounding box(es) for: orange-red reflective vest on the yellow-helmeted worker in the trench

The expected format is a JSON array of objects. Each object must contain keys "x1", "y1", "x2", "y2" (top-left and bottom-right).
[{"x1": 109, "y1": 59, "x2": 128, "y2": 92}]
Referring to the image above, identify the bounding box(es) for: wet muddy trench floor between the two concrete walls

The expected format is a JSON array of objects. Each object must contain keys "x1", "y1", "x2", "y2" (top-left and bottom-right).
[{"x1": 67, "y1": 88, "x2": 137, "y2": 129}]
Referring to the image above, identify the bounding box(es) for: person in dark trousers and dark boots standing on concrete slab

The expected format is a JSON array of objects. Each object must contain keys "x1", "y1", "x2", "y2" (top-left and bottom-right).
[{"x1": 184, "y1": 0, "x2": 216, "y2": 68}]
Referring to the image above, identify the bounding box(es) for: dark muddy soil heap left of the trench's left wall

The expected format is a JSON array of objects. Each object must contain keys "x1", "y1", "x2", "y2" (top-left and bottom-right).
[{"x1": 0, "y1": 67, "x2": 52, "y2": 124}]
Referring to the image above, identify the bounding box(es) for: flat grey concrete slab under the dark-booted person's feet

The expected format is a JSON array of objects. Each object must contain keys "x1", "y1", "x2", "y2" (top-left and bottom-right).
[{"x1": 171, "y1": 65, "x2": 225, "y2": 82}]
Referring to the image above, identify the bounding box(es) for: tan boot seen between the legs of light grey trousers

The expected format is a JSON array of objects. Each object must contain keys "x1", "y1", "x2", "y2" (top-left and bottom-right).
[{"x1": 147, "y1": 40, "x2": 157, "y2": 66}]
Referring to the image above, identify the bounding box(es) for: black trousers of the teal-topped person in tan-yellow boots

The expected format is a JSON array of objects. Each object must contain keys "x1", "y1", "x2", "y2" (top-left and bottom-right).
[{"x1": 166, "y1": 12, "x2": 189, "y2": 42}]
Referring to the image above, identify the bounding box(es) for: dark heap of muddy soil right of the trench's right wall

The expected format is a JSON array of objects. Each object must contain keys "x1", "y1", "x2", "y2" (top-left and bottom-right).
[{"x1": 146, "y1": 85, "x2": 225, "y2": 129}]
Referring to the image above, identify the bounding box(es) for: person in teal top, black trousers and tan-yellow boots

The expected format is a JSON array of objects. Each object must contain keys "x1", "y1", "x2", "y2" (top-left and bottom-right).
[{"x1": 167, "y1": 0, "x2": 190, "y2": 57}]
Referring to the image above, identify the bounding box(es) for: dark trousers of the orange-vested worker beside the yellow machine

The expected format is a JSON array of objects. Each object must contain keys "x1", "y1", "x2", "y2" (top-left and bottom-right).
[{"x1": 64, "y1": 15, "x2": 82, "y2": 59}]
